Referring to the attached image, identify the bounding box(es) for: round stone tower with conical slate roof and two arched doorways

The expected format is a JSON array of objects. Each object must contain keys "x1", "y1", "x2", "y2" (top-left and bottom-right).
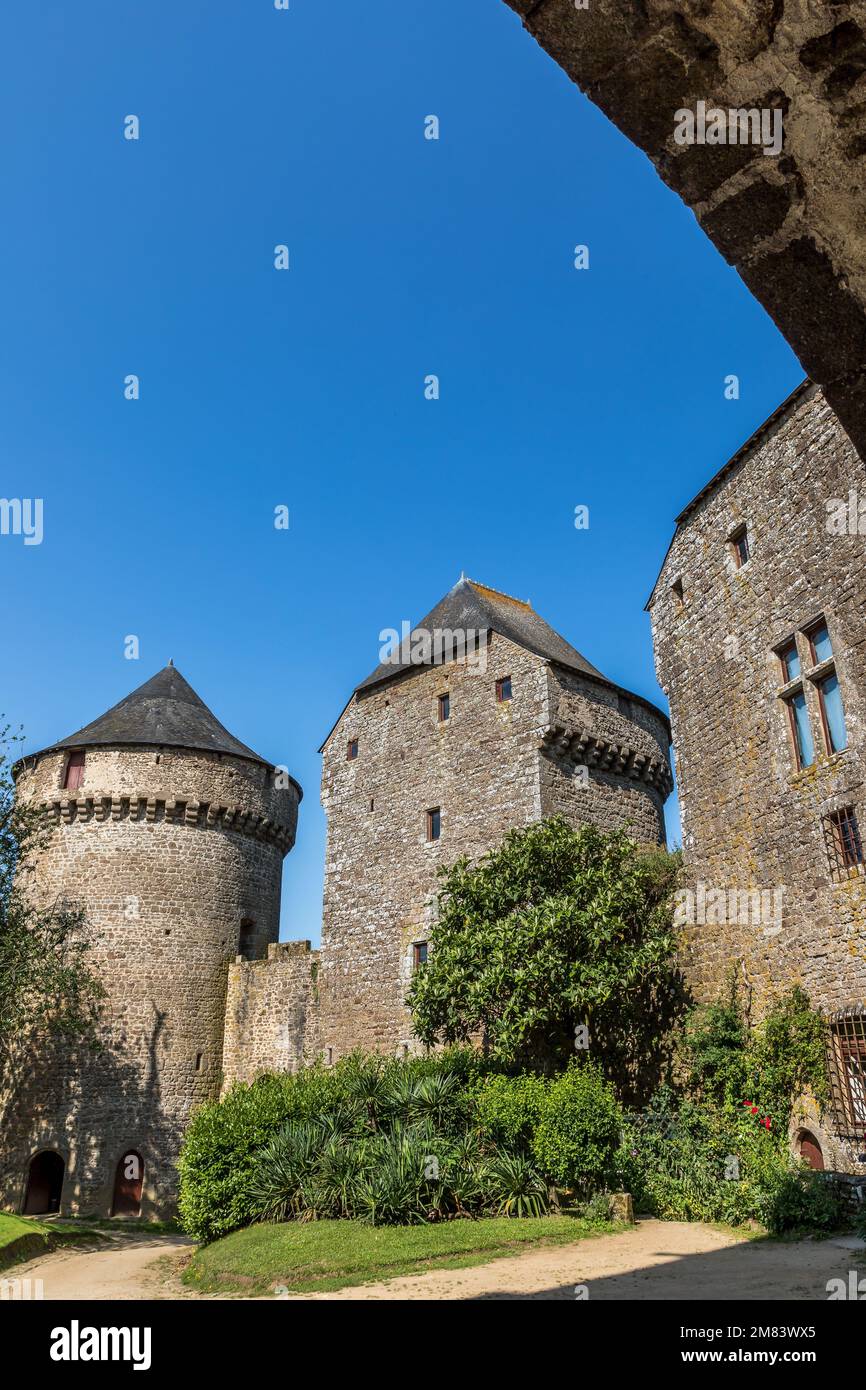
[{"x1": 0, "y1": 664, "x2": 302, "y2": 1218}]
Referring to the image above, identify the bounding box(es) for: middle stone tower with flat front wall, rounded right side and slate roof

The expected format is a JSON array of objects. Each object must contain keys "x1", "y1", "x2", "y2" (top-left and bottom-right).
[{"x1": 318, "y1": 580, "x2": 671, "y2": 1061}]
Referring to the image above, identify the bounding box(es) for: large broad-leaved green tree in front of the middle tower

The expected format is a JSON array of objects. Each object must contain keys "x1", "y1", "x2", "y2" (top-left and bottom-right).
[{"x1": 409, "y1": 819, "x2": 681, "y2": 1095}]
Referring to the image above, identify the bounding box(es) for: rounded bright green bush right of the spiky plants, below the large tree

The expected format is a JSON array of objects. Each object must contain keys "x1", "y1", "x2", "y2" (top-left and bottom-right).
[{"x1": 532, "y1": 1062, "x2": 623, "y2": 1197}]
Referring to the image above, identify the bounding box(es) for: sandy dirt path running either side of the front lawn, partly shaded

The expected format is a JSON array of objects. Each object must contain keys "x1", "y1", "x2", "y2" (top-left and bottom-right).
[{"x1": 10, "y1": 1220, "x2": 863, "y2": 1301}]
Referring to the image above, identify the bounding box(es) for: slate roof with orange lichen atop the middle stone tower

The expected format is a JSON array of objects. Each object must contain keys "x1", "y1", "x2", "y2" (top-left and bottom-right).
[{"x1": 356, "y1": 578, "x2": 610, "y2": 691}]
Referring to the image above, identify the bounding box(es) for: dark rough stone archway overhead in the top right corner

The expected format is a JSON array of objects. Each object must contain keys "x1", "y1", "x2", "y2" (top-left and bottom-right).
[{"x1": 506, "y1": 0, "x2": 866, "y2": 456}]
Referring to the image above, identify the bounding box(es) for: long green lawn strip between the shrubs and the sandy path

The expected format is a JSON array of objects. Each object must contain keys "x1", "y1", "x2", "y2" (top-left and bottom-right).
[{"x1": 183, "y1": 1216, "x2": 627, "y2": 1297}]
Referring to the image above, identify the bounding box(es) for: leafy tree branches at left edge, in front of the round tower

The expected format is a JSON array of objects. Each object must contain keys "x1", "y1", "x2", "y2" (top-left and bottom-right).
[{"x1": 0, "y1": 728, "x2": 104, "y2": 1090}]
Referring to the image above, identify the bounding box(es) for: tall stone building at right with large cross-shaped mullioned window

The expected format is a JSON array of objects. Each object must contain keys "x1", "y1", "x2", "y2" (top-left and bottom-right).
[{"x1": 648, "y1": 382, "x2": 866, "y2": 1170}]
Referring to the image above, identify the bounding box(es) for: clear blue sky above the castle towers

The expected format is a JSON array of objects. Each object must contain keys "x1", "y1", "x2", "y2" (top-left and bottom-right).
[{"x1": 0, "y1": 0, "x2": 802, "y2": 940}]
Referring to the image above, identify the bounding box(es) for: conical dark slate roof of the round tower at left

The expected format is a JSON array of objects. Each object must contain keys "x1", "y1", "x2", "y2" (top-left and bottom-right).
[{"x1": 44, "y1": 663, "x2": 271, "y2": 767}]
